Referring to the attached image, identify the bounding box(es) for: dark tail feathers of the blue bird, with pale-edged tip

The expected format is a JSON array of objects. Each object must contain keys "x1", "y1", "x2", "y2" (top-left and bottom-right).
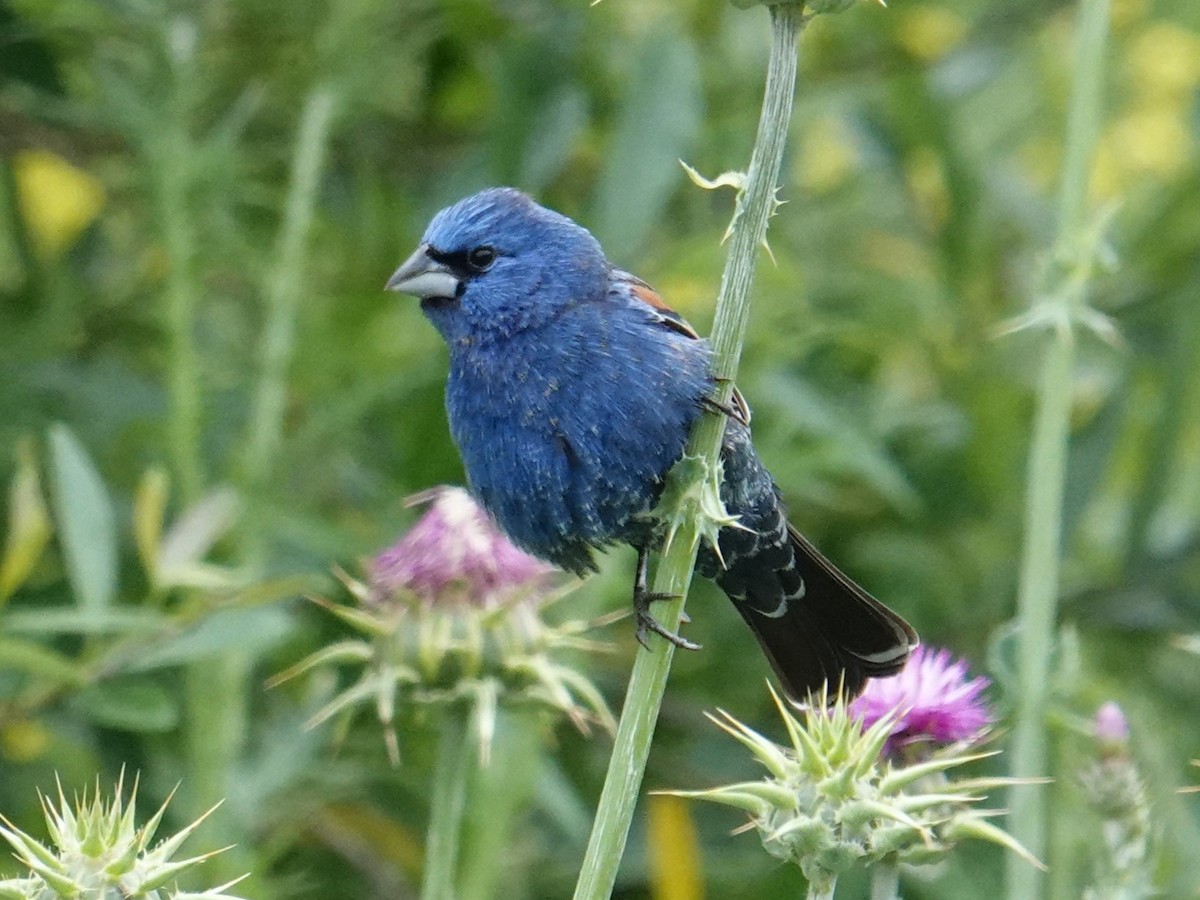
[{"x1": 715, "y1": 524, "x2": 917, "y2": 702}]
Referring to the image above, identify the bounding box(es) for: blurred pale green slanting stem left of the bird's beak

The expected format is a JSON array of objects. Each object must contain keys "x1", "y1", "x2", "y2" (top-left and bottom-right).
[{"x1": 246, "y1": 85, "x2": 336, "y2": 511}]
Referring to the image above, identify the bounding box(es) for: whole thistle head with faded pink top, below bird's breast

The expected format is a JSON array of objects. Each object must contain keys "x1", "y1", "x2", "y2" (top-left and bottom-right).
[{"x1": 272, "y1": 487, "x2": 613, "y2": 763}]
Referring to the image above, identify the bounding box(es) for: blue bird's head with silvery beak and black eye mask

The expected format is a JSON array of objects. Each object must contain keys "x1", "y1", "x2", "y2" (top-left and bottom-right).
[{"x1": 386, "y1": 187, "x2": 608, "y2": 346}]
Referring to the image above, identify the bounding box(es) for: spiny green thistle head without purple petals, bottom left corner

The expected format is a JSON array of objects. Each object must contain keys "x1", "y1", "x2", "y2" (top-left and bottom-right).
[{"x1": 0, "y1": 772, "x2": 245, "y2": 900}]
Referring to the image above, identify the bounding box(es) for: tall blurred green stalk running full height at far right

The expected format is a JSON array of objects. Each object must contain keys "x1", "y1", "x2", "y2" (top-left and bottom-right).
[{"x1": 1007, "y1": 0, "x2": 1110, "y2": 900}]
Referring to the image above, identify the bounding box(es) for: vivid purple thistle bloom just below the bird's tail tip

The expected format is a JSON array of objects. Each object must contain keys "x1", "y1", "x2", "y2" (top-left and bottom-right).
[{"x1": 851, "y1": 647, "x2": 992, "y2": 756}]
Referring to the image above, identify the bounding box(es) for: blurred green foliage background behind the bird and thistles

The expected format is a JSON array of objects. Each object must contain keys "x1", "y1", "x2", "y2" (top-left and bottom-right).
[{"x1": 0, "y1": 0, "x2": 1200, "y2": 900}]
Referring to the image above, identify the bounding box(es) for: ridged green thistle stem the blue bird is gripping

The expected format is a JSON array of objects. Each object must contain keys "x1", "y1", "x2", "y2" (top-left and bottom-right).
[{"x1": 575, "y1": 4, "x2": 804, "y2": 900}]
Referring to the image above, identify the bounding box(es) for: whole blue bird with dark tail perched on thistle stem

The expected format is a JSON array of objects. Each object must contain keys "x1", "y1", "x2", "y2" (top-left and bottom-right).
[{"x1": 386, "y1": 188, "x2": 917, "y2": 700}]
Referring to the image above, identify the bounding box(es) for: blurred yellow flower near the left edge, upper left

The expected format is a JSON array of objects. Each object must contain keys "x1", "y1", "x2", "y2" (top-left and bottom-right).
[{"x1": 13, "y1": 150, "x2": 104, "y2": 259}]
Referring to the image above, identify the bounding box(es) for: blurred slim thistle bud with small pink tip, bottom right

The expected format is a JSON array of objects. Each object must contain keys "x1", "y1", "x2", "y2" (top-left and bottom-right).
[{"x1": 1080, "y1": 702, "x2": 1158, "y2": 900}]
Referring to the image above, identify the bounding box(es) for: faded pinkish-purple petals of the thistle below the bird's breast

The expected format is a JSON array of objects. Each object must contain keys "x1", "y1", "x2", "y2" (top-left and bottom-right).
[{"x1": 368, "y1": 486, "x2": 554, "y2": 606}]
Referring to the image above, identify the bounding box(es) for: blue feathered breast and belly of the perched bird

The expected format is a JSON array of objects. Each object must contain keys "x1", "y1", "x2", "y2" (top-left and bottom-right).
[{"x1": 446, "y1": 294, "x2": 710, "y2": 571}]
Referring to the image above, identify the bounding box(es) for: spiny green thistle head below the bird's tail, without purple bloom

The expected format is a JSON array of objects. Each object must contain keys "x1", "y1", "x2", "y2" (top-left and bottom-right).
[{"x1": 672, "y1": 695, "x2": 1036, "y2": 890}]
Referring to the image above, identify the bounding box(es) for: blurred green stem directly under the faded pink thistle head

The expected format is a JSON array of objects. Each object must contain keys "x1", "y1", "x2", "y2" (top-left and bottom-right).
[{"x1": 421, "y1": 709, "x2": 479, "y2": 900}]
